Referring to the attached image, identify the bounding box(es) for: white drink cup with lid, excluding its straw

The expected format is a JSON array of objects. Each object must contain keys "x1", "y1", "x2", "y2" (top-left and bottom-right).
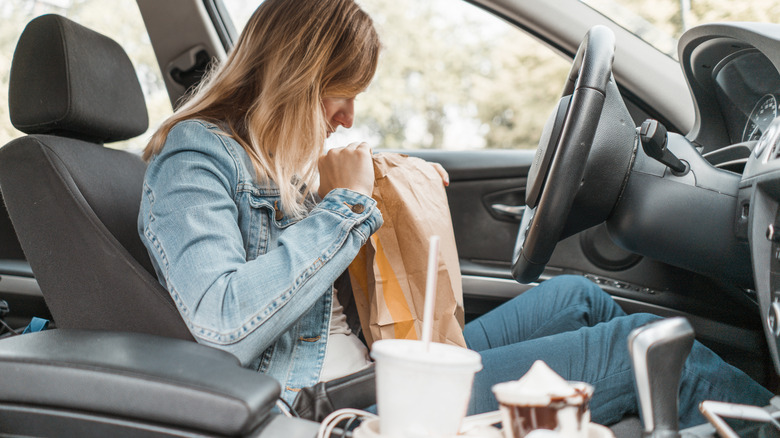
[{"x1": 371, "y1": 339, "x2": 482, "y2": 438}]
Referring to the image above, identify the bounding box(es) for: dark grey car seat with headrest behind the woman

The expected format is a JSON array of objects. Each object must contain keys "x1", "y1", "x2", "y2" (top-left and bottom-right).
[{"x1": 0, "y1": 15, "x2": 194, "y2": 341}]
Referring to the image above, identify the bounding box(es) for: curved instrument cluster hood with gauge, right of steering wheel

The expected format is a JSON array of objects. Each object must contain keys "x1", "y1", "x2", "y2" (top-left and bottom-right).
[{"x1": 679, "y1": 23, "x2": 780, "y2": 156}]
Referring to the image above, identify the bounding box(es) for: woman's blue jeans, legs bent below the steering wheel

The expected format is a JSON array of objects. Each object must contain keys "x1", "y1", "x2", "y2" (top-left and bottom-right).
[{"x1": 463, "y1": 276, "x2": 772, "y2": 428}]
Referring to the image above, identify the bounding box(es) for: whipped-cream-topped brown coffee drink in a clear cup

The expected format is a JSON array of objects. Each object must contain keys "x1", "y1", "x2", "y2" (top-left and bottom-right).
[{"x1": 493, "y1": 361, "x2": 593, "y2": 438}]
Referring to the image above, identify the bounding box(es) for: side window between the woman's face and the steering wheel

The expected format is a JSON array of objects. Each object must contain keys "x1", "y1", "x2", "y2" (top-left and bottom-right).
[{"x1": 224, "y1": 0, "x2": 570, "y2": 149}]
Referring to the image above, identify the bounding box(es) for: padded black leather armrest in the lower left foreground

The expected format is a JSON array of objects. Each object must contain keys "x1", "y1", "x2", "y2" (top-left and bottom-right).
[{"x1": 0, "y1": 329, "x2": 281, "y2": 436}]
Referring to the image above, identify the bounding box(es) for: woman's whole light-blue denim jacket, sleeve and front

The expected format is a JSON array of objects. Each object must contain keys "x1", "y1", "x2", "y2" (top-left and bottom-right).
[{"x1": 138, "y1": 120, "x2": 382, "y2": 401}]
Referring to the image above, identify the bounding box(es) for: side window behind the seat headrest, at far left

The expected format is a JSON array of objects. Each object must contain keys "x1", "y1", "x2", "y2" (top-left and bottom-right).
[{"x1": 0, "y1": 0, "x2": 172, "y2": 152}]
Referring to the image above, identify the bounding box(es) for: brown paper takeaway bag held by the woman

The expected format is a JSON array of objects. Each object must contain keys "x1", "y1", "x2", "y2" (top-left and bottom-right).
[{"x1": 349, "y1": 153, "x2": 466, "y2": 347}]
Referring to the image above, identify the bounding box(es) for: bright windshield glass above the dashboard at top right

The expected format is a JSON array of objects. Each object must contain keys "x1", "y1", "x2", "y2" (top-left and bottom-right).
[{"x1": 580, "y1": 0, "x2": 780, "y2": 59}]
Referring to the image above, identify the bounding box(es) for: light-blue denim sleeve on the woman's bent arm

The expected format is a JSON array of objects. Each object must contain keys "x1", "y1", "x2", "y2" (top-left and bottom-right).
[{"x1": 139, "y1": 122, "x2": 382, "y2": 364}]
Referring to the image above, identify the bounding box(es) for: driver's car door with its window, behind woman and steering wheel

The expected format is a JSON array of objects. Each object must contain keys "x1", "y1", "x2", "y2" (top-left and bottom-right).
[{"x1": 138, "y1": 0, "x2": 768, "y2": 386}]
